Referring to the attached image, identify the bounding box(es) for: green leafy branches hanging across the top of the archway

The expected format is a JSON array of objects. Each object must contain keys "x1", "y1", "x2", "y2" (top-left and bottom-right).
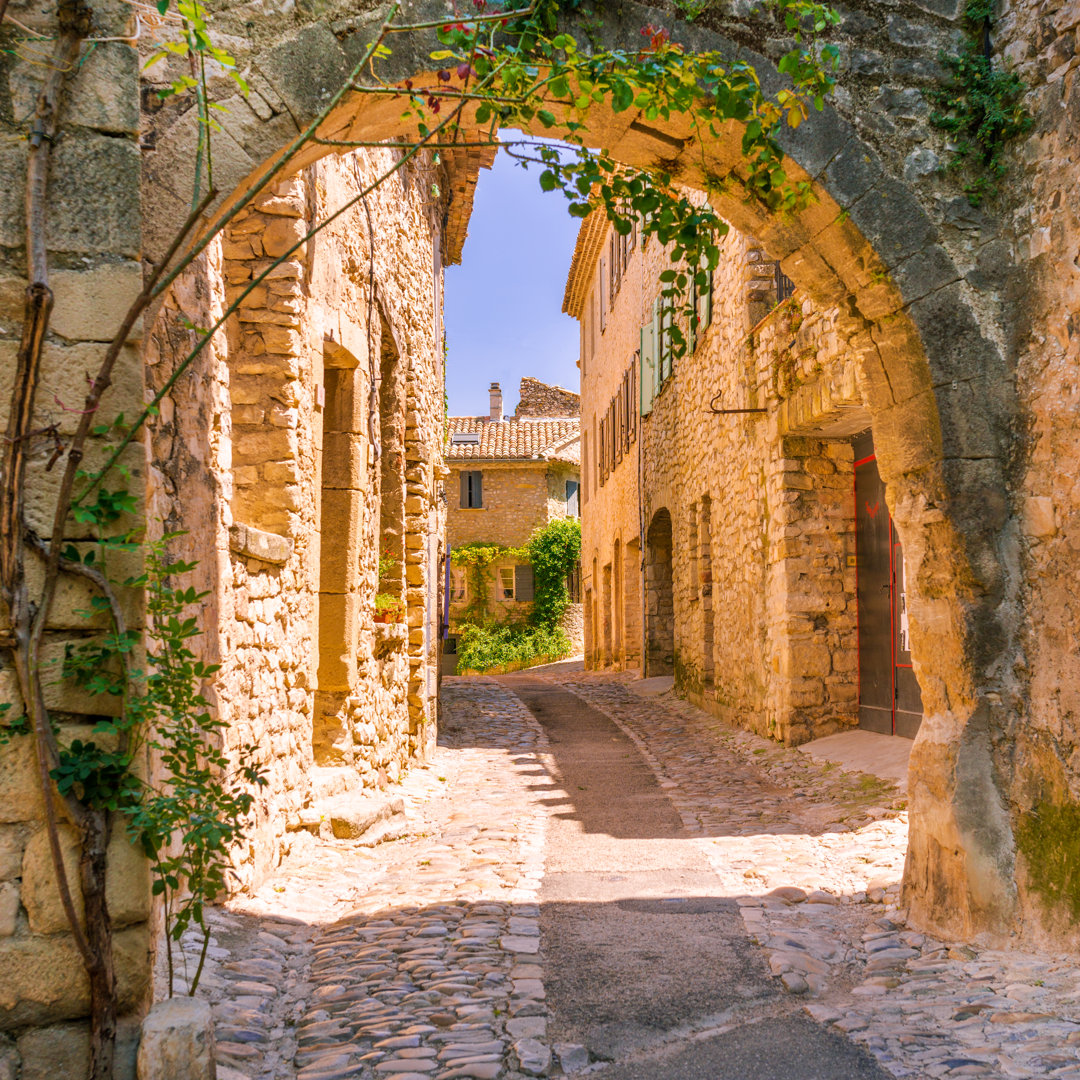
[{"x1": 416, "y1": 0, "x2": 839, "y2": 356}]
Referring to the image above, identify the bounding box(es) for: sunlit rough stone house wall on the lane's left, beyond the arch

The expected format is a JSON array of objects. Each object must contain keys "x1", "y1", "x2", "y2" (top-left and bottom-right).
[{"x1": 151, "y1": 151, "x2": 443, "y2": 887}]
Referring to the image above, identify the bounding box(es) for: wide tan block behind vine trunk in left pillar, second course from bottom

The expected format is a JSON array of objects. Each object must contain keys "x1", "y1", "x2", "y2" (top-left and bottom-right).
[{"x1": 0, "y1": 924, "x2": 150, "y2": 1031}]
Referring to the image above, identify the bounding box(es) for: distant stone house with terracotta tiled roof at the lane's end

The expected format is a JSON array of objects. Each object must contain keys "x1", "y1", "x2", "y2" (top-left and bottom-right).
[{"x1": 446, "y1": 377, "x2": 582, "y2": 649}]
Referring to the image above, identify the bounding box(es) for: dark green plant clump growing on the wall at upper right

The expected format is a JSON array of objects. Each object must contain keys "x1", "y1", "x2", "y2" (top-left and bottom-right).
[{"x1": 929, "y1": 0, "x2": 1034, "y2": 206}]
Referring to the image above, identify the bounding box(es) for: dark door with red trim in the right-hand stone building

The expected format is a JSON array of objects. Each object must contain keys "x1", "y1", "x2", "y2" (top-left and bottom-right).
[{"x1": 854, "y1": 432, "x2": 922, "y2": 739}]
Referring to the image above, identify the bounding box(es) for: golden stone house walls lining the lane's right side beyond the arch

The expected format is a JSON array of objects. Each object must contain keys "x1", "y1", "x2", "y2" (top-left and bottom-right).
[{"x1": 582, "y1": 219, "x2": 868, "y2": 742}]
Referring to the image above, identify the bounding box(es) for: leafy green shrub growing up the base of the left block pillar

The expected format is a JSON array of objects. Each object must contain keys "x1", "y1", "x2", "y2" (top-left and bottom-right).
[{"x1": 59, "y1": 531, "x2": 266, "y2": 993}]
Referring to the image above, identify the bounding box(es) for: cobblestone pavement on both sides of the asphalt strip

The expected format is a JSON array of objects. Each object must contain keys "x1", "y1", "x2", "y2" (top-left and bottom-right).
[{"x1": 170, "y1": 672, "x2": 1080, "y2": 1080}]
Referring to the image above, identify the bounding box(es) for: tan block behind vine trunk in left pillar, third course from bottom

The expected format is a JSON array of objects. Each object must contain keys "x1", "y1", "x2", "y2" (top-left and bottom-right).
[{"x1": 23, "y1": 826, "x2": 150, "y2": 934}]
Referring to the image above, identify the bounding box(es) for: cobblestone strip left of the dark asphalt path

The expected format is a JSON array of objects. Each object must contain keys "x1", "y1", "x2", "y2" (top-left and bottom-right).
[{"x1": 170, "y1": 678, "x2": 551, "y2": 1080}]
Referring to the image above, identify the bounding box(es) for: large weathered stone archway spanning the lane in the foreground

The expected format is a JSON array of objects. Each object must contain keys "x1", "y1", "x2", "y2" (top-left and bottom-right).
[{"x1": 144, "y1": 4, "x2": 1032, "y2": 933}]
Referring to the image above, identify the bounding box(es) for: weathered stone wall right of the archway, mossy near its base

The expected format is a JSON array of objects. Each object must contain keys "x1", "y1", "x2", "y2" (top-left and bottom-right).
[{"x1": 976, "y1": 0, "x2": 1080, "y2": 947}]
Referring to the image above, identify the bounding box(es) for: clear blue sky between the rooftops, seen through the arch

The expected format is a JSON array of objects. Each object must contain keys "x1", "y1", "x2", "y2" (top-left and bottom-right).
[{"x1": 445, "y1": 140, "x2": 581, "y2": 416}]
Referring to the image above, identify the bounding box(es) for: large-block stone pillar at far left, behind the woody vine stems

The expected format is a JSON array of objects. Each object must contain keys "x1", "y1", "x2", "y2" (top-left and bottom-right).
[{"x1": 0, "y1": 0, "x2": 150, "y2": 1080}]
